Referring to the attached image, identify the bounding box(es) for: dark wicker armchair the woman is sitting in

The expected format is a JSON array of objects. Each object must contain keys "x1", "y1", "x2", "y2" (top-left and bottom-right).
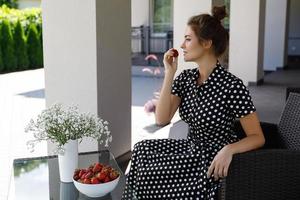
[{"x1": 218, "y1": 93, "x2": 300, "y2": 200}]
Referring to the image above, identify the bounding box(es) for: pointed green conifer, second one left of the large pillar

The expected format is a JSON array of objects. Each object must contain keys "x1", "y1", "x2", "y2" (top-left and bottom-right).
[{"x1": 14, "y1": 21, "x2": 29, "y2": 70}]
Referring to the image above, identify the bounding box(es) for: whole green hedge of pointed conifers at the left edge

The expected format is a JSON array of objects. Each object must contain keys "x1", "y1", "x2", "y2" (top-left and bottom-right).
[{"x1": 0, "y1": 5, "x2": 43, "y2": 73}]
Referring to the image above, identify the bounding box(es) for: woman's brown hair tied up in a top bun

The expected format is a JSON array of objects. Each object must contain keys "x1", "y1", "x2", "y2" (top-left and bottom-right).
[{"x1": 187, "y1": 6, "x2": 229, "y2": 57}]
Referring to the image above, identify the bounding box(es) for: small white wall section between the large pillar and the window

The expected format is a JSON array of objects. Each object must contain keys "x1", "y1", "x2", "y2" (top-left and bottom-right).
[{"x1": 131, "y1": 0, "x2": 150, "y2": 26}]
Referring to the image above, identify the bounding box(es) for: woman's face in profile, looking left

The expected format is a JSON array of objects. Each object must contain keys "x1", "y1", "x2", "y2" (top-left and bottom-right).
[{"x1": 180, "y1": 26, "x2": 211, "y2": 62}]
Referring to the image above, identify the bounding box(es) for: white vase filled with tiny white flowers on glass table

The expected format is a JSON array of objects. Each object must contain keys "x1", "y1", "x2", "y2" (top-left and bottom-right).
[{"x1": 25, "y1": 104, "x2": 112, "y2": 182}]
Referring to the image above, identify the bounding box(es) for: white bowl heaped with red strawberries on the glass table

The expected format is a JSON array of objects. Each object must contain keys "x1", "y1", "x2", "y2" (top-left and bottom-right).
[{"x1": 73, "y1": 163, "x2": 120, "y2": 197}]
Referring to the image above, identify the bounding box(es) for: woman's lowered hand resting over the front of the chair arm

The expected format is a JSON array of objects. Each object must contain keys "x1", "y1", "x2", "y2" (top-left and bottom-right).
[{"x1": 207, "y1": 145, "x2": 233, "y2": 181}]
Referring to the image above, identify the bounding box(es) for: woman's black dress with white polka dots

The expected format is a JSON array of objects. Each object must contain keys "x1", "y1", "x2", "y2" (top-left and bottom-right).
[{"x1": 122, "y1": 62, "x2": 256, "y2": 200}]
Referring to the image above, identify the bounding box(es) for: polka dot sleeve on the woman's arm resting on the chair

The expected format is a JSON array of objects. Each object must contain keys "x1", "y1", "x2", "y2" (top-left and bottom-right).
[{"x1": 228, "y1": 79, "x2": 256, "y2": 118}]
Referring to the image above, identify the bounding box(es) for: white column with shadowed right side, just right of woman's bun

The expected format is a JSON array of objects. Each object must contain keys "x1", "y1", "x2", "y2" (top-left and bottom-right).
[{"x1": 229, "y1": 0, "x2": 265, "y2": 85}]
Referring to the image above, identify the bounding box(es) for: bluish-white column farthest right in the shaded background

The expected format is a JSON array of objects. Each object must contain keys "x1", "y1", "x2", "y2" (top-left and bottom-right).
[{"x1": 264, "y1": 0, "x2": 288, "y2": 71}]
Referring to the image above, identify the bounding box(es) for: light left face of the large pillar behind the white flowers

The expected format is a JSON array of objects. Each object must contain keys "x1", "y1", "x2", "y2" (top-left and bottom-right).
[{"x1": 42, "y1": 0, "x2": 98, "y2": 152}]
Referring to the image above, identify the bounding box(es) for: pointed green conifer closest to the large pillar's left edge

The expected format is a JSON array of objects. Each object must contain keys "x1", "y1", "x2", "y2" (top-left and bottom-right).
[{"x1": 27, "y1": 24, "x2": 43, "y2": 69}]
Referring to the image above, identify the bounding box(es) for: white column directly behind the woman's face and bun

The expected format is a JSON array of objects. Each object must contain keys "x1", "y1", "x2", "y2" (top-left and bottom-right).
[{"x1": 173, "y1": 0, "x2": 212, "y2": 74}]
